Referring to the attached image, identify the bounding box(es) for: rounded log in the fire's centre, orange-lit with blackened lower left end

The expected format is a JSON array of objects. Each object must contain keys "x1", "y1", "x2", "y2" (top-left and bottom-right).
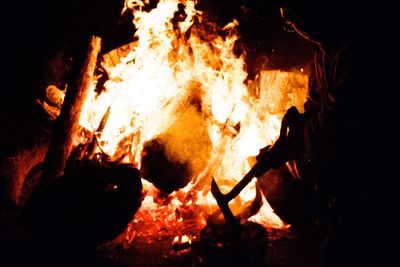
[{"x1": 140, "y1": 104, "x2": 212, "y2": 194}]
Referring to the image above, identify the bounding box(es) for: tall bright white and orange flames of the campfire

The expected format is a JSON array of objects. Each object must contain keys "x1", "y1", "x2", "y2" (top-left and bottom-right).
[{"x1": 80, "y1": 0, "x2": 307, "y2": 245}]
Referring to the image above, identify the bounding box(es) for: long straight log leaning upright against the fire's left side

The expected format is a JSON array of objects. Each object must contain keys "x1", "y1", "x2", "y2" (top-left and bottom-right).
[{"x1": 41, "y1": 36, "x2": 101, "y2": 183}]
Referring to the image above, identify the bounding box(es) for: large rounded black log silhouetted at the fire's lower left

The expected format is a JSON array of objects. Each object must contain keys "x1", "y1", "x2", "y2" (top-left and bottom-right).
[{"x1": 23, "y1": 160, "x2": 142, "y2": 247}]
